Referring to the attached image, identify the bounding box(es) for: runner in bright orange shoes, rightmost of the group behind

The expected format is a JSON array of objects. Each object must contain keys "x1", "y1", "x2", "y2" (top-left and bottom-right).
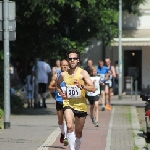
[{"x1": 105, "y1": 58, "x2": 116, "y2": 110}]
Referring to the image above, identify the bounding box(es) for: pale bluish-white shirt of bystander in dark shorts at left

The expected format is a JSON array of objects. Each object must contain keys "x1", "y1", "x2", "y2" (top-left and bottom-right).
[{"x1": 32, "y1": 61, "x2": 51, "y2": 83}]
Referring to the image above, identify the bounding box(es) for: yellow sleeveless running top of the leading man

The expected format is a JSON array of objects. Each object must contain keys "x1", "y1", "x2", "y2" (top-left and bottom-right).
[{"x1": 63, "y1": 67, "x2": 87, "y2": 112}]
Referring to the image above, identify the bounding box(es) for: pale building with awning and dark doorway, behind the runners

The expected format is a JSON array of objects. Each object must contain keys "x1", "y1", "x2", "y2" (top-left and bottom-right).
[{"x1": 81, "y1": 0, "x2": 150, "y2": 90}]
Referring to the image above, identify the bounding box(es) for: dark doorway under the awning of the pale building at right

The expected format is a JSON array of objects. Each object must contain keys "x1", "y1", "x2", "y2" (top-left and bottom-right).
[{"x1": 124, "y1": 50, "x2": 142, "y2": 90}]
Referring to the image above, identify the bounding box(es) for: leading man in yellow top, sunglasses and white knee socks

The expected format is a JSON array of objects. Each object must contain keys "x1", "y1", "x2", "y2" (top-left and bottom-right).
[{"x1": 57, "y1": 49, "x2": 95, "y2": 150}]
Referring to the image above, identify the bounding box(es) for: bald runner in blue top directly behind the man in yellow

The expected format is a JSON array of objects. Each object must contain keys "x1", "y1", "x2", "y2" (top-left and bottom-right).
[{"x1": 48, "y1": 60, "x2": 68, "y2": 146}]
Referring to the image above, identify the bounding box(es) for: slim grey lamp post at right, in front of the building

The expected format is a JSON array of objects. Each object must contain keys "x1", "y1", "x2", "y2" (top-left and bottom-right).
[{"x1": 118, "y1": 0, "x2": 122, "y2": 100}]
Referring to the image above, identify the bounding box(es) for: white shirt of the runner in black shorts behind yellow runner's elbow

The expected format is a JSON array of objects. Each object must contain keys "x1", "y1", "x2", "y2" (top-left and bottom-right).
[{"x1": 87, "y1": 76, "x2": 100, "y2": 96}]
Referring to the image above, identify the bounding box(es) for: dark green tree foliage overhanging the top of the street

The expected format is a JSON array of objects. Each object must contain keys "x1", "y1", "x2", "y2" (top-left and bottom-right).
[{"x1": 9, "y1": 0, "x2": 144, "y2": 58}]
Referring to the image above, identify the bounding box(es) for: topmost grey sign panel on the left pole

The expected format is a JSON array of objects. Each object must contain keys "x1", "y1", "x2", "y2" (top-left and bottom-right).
[{"x1": 0, "y1": 1, "x2": 16, "y2": 20}]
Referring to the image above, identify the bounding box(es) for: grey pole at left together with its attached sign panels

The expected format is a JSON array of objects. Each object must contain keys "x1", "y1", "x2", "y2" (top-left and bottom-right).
[{"x1": 0, "y1": 0, "x2": 16, "y2": 129}]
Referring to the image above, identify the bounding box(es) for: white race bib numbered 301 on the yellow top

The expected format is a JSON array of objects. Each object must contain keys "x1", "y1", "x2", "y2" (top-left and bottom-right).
[{"x1": 67, "y1": 85, "x2": 81, "y2": 98}]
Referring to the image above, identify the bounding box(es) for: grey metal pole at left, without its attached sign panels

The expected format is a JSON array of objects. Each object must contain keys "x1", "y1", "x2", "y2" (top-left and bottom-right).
[{"x1": 3, "y1": 0, "x2": 10, "y2": 129}]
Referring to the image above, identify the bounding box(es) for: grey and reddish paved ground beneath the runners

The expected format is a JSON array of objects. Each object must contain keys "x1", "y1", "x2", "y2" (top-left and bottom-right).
[{"x1": 0, "y1": 95, "x2": 147, "y2": 150}]
